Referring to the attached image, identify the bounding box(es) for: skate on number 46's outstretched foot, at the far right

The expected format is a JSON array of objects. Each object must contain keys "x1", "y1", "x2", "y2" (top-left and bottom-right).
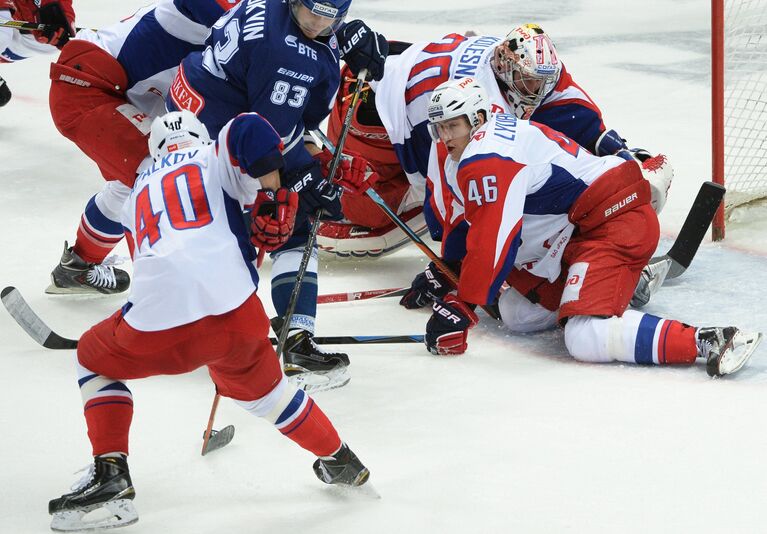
[{"x1": 695, "y1": 326, "x2": 762, "y2": 376}]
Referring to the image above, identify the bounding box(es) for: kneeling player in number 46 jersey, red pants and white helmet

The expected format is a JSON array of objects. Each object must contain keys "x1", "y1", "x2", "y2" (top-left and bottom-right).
[{"x1": 426, "y1": 78, "x2": 761, "y2": 382}]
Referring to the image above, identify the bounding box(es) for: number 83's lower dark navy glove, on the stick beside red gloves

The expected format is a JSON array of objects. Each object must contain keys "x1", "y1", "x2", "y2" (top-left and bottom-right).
[{"x1": 284, "y1": 161, "x2": 343, "y2": 221}]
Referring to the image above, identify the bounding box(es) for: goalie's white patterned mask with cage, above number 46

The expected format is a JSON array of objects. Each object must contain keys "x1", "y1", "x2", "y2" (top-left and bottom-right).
[{"x1": 490, "y1": 24, "x2": 562, "y2": 112}]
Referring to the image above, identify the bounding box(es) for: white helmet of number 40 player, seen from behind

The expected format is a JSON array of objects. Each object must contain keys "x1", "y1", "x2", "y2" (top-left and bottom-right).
[{"x1": 149, "y1": 109, "x2": 210, "y2": 161}]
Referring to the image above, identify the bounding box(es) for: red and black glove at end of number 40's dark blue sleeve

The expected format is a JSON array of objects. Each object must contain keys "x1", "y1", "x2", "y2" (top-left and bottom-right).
[{"x1": 250, "y1": 187, "x2": 298, "y2": 252}]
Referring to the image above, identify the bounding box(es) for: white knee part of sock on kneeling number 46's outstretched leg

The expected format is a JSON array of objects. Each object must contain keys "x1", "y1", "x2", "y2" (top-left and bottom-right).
[{"x1": 565, "y1": 315, "x2": 621, "y2": 363}]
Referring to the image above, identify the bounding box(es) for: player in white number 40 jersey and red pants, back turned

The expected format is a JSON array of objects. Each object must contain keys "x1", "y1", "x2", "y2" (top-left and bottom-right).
[{"x1": 48, "y1": 111, "x2": 370, "y2": 530}]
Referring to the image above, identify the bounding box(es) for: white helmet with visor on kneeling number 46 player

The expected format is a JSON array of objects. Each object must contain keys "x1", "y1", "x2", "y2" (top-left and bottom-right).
[{"x1": 427, "y1": 78, "x2": 490, "y2": 142}]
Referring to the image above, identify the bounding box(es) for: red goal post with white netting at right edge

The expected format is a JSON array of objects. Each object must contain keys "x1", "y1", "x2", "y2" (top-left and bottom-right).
[{"x1": 711, "y1": 0, "x2": 767, "y2": 240}]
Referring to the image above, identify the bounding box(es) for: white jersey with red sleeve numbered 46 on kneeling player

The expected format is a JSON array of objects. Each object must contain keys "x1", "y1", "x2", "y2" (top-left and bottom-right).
[{"x1": 445, "y1": 114, "x2": 625, "y2": 304}]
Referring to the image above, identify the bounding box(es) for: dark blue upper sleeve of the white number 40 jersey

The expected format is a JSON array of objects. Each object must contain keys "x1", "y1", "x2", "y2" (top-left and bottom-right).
[{"x1": 226, "y1": 113, "x2": 285, "y2": 178}]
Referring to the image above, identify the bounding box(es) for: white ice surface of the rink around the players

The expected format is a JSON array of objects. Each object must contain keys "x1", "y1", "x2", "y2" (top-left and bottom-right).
[{"x1": 0, "y1": 0, "x2": 767, "y2": 534}]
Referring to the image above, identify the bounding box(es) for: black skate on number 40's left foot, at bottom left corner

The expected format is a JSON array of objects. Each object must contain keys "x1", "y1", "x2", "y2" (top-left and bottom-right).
[{"x1": 48, "y1": 457, "x2": 138, "y2": 532}]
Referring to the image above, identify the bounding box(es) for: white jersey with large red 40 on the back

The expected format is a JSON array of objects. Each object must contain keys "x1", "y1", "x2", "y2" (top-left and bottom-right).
[{"x1": 122, "y1": 113, "x2": 283, "y2": 331}]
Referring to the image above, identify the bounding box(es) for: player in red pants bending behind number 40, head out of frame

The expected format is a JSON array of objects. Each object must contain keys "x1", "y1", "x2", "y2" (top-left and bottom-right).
[{"x1": 46, "y1": 0, "x2": 238, "y2": 294}]
